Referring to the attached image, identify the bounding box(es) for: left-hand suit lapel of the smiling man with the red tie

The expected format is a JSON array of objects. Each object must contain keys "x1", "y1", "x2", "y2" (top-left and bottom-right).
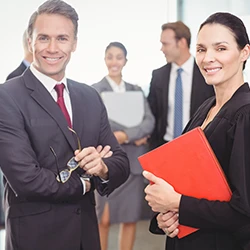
[{"x1": 24, "y1": 69, "x2": 76, "y2": 150}]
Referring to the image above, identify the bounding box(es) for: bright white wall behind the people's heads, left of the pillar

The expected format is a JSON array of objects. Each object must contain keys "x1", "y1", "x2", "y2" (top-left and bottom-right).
[{"x1": 0, "y1": 0, "x2": 173, "y2": 92}]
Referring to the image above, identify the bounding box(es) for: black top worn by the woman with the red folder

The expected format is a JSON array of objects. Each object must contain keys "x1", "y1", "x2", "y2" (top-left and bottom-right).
[{"x1": 150, "y1": 83, "x2": 250, "y2": 250}]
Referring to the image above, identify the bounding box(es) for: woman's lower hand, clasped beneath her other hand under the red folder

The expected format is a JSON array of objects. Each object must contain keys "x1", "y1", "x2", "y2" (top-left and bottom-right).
[{"x1": 156, "y1": 211, "x2": 179, "y2": 238}]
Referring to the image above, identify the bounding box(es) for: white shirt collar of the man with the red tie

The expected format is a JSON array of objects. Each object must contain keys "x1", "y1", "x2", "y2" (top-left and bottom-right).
[{"x1": 30, "y1": 63, "x2": 69, "y2": 93}]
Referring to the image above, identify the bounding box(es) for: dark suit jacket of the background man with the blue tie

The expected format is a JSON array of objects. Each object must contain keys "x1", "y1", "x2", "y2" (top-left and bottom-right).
[{"x1": 148, "y1": 63, "x2": 214, "y2": 148}]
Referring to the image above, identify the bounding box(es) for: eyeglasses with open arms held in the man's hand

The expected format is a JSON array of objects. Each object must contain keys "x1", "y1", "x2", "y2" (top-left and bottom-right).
[{"x1": 50, "y1": 127, "x2": 82, "y2": 183}]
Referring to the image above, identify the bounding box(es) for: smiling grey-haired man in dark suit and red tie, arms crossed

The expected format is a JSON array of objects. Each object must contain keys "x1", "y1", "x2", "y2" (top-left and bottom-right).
[{"x1": 0, "y1": 0, "x2": 129, "y2": 250}]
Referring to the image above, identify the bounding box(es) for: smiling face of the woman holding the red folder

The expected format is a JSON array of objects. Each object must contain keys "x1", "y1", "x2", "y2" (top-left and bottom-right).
[{"x1": 196, "y1": 24, "x2": 249, "y2": 85}]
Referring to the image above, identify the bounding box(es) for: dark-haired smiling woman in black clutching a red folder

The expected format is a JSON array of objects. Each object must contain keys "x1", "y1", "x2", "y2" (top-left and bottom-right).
[{"x1": 144, "y1": 13, "x2": 250, "y2": 250}]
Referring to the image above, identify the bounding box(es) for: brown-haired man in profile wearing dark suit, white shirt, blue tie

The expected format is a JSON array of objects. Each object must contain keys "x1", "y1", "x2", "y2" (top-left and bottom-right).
[{"x1": 148, "y1": 21, "x2": 214, "y2": 148}]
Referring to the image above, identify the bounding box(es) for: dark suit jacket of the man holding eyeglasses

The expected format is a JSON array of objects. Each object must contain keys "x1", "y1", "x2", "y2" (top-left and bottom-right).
[{"x1": 0, "y1": 69, "x2": 129, "y2": 250}]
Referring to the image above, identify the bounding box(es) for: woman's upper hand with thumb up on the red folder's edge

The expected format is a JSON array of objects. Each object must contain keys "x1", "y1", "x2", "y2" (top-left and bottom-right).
[{"x1": 143, "y1": 171, "x2": 181, "y2": 213}]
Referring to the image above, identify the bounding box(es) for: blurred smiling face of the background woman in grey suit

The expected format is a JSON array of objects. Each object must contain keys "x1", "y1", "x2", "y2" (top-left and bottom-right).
[{"x1": 104, "y1": 46, "x2": 127, "y2": 77}]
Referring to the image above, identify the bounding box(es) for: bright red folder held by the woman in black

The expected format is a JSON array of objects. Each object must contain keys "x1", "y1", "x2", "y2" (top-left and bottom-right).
[{"x1": 138, "y1": 127, "x2": 232, "y2": 238}]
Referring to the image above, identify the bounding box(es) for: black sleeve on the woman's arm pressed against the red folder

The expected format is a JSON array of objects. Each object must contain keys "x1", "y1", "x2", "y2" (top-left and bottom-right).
[{"x1": 179, "y1": 107, "x2": 250, "y2": 239}]
